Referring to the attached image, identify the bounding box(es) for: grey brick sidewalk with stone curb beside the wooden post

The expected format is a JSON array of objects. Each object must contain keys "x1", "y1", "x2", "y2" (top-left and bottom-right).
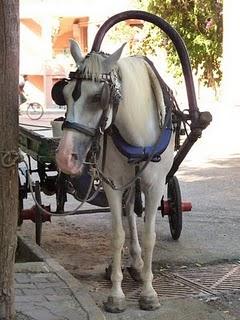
[{"x1": 15, "y1": 238, "x2": 104, "y2": 320}]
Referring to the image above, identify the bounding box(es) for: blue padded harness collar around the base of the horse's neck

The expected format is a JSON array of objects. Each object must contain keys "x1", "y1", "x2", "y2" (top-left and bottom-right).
[{"x1": 111, "y1": 57, "x2": 172, "y2": 163}]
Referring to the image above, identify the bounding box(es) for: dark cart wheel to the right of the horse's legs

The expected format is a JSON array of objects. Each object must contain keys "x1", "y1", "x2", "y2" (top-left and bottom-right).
[{"x1": 167, "y1": 176, "x2": 182, "y2": 240}]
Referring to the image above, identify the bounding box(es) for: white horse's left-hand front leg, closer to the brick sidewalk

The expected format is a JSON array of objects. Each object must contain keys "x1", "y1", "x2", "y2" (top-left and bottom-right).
[{"x1": 104, "y1": 186, "x2": 126, "y2": 313}]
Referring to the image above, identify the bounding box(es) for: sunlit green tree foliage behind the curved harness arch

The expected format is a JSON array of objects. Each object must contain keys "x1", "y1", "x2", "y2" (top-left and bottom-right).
[{"x1": 138, "y1": 0, "x2": 223, "y2": 87}]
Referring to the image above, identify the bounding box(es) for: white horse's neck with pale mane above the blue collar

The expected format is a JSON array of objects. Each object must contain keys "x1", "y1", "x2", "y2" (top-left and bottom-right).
[{"x1": 115, "y1": 58, "x2": 163, "y2": 146}]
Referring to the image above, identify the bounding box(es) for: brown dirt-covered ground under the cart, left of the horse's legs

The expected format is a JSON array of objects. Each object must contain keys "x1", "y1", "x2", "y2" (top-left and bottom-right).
[{"x1": 21, "y1": 206, "x2": 114, "y2": 279}]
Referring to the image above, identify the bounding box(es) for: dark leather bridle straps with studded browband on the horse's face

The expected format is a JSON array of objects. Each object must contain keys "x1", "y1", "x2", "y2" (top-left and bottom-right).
[{"x1": 62, "y1": 70, "x2": 121, "y2": 137}]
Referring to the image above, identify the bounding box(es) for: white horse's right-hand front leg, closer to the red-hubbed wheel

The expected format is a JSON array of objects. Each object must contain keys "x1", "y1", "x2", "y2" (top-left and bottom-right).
[{"x1": 139, "y1": 188, "x2": 160, "y2": 310}]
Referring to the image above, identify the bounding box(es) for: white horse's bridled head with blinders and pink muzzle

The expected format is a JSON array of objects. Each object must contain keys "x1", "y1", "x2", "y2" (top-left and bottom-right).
[{"x1": 52, "y1": 40, "x2": 124, "y2": 175}]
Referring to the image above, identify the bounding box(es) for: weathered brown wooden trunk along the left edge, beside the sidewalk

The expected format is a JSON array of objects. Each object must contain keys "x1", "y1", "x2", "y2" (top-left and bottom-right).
[{"x1": 0, "y1": 0, "x2": 19, "y2": 320}]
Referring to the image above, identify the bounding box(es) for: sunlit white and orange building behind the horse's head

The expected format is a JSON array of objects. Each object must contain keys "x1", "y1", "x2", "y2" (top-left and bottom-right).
[{"x1": 20, "y1": 0, "x2": 139, "y2": 107}]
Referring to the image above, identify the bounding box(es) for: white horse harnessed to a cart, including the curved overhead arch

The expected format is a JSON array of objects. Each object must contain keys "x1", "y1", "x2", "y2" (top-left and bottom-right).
[{"x1": 20, "y1": 11, "x2": 211, "y2": 312}]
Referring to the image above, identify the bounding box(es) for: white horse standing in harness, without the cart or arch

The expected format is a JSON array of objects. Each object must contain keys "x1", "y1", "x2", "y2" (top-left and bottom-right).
[{"x1": 56, "y1": 40, "x2": 174, "y2": 312}]
